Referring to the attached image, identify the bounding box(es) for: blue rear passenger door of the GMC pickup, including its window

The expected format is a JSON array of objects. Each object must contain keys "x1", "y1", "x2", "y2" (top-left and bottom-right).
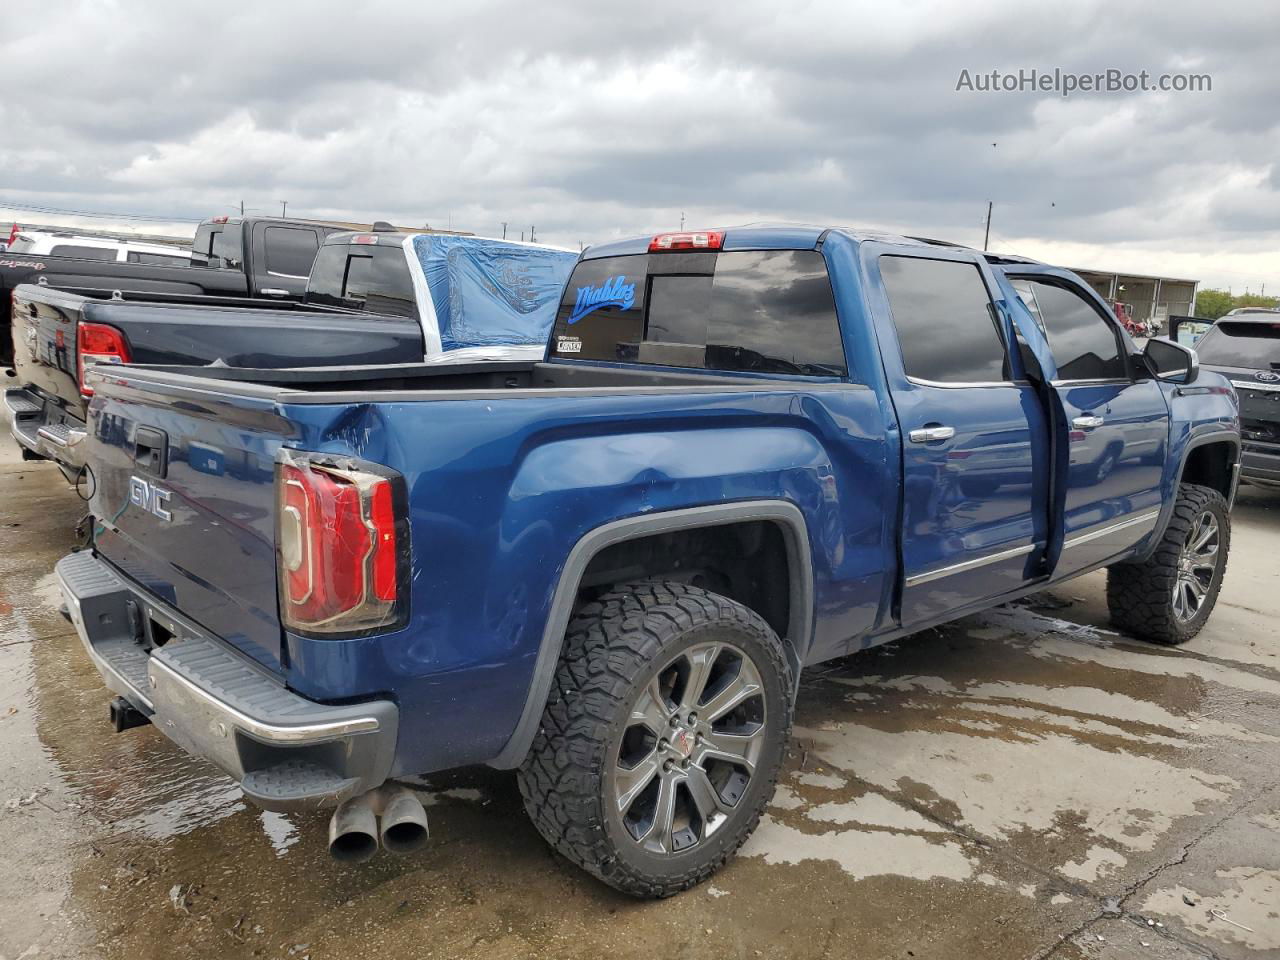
[{"x1": 864, "y1": 244, "x2": 1050, "y2": 626}]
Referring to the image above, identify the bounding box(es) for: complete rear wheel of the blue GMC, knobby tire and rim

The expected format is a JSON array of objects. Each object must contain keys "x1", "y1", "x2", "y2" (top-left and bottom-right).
[{"x1": 518, "y1": 581, "x2": 792, "y2": 897}]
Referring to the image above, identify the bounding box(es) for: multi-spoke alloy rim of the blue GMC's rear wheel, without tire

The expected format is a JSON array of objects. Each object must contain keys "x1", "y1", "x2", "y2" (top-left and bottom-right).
[{"x1": 612, "y1": 641, "x2": 767, "y2": 854}]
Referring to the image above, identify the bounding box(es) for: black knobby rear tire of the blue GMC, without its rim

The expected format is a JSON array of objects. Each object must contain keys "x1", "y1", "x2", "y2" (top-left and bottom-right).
[{"x1": 517, "y1": 581, "x2": 794, "y2": 899}]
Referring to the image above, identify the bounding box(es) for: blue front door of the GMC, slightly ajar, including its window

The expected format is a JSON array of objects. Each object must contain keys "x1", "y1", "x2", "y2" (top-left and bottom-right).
[{"x1": 1011, "y1": 274, "x2": 1169, "y2": 575}]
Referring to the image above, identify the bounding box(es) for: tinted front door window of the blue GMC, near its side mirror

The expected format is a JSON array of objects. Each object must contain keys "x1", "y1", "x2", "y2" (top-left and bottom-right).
[{"x1": 1014, "y1": 278, "x2": 1129, "y2": 380}]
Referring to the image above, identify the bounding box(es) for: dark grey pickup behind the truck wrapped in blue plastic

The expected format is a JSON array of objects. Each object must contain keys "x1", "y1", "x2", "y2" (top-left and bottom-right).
[{"x1": 0, "y1": 216, "x2": 366, "y2": 367}]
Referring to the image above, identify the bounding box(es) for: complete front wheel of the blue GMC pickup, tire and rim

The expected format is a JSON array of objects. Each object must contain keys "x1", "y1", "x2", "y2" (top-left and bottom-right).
[{"x1": 1107, "y1": 484, "x2": 1231, "y2": 644}]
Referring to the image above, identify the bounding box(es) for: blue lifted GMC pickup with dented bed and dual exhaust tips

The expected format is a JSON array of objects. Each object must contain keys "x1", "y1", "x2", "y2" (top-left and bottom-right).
[{"x1": 58, "y1": 227, "x2": 1240, "y2": 896}]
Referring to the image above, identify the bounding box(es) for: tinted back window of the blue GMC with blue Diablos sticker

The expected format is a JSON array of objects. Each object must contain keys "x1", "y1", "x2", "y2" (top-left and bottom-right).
[{"x1": 550, "y1": 250, "x2": 847, "y2": 376}]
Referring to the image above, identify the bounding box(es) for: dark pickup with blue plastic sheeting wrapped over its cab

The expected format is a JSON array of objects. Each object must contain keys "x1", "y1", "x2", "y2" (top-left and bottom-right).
[{"x1": 4, "y1": 224, "x2": 577, "y2": 483}]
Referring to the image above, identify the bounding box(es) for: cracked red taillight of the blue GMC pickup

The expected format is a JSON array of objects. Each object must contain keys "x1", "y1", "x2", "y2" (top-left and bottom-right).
[{"x1": 276, "y1": 454, "x2": 401, "y2": 634}]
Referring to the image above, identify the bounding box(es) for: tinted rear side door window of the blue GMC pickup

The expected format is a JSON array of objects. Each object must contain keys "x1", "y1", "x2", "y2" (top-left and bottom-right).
[{"x1": 879, "y1": 256, "x2": 1011, "y2": 385}]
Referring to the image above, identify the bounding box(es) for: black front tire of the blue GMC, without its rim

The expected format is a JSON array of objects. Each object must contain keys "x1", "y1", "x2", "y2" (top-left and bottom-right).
[{"x1": 1107, "y1": 484, "x2": 1231, "y2": 645}]
